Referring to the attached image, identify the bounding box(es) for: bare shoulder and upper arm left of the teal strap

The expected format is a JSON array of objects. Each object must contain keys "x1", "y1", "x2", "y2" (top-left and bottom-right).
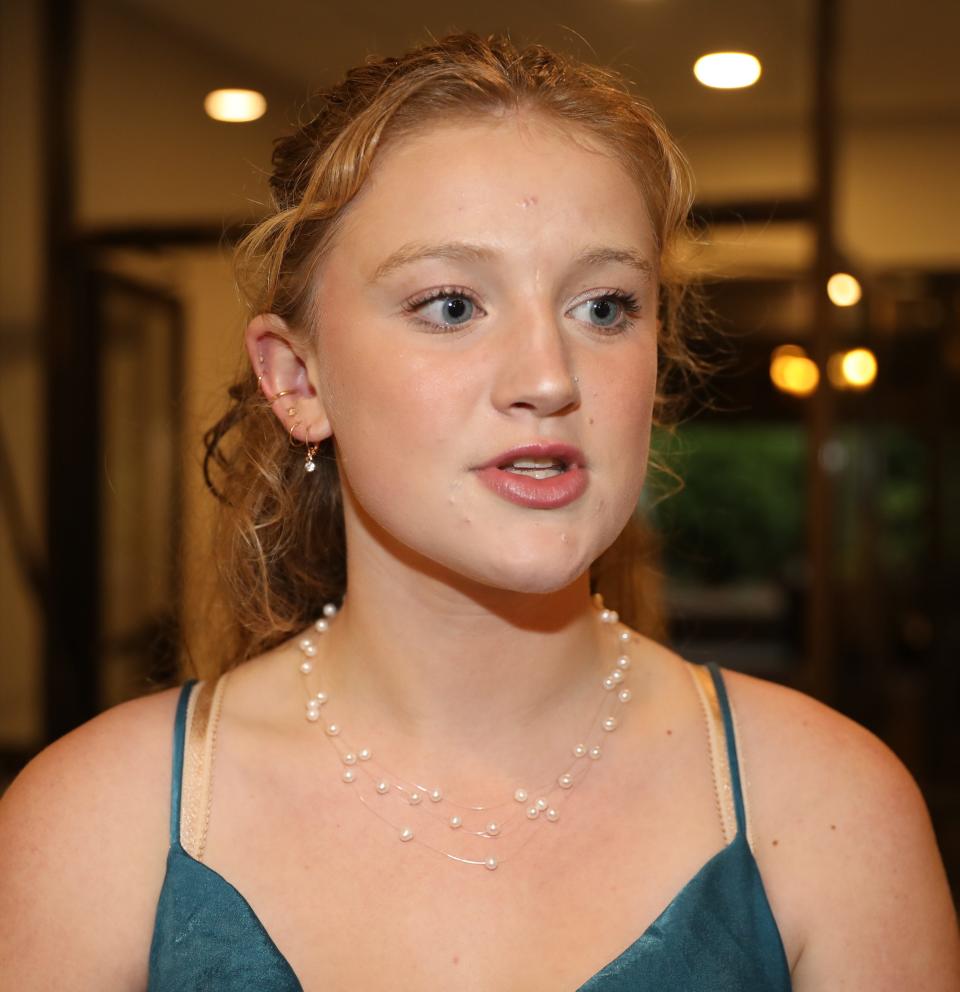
[{"x1": 0, "y1": 689, "x2": 186, "y2": 990}]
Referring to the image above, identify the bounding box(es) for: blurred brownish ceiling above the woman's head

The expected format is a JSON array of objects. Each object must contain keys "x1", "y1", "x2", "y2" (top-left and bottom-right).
[{"x1": 118, "y1": 0, "x2": 960, "y2": 128}]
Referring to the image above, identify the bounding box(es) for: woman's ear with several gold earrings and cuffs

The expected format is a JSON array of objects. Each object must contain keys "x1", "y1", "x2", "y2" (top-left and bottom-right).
[{"x1": 245, "y1": 313, "x2": 333, "y2": 443}]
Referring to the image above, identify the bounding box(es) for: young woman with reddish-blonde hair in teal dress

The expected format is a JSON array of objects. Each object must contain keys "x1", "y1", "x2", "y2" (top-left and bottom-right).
[{"x1": 0, "y1": 36, "x2": 960, "y2": 992}]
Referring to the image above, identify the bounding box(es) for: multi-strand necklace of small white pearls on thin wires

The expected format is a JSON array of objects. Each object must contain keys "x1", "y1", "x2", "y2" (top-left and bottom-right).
[{"x1": 297, "y1": 594, "x2": 632, "y2": 871}]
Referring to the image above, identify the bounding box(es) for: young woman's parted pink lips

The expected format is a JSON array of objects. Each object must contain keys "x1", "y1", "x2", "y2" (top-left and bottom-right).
[{"x1": 476, "y1": 443, "x2": 588, "y2": 510}]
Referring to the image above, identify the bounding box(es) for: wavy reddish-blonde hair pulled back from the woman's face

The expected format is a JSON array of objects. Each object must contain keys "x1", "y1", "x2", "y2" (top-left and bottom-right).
[{"x1": 195, "y1": 34, "x2": 698, "y2": 670}]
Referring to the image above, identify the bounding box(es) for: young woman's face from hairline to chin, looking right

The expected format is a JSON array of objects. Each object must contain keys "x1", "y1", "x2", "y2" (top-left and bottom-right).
[{"x1": 308, "y1": 115, "x2": 657, "y2": 592}]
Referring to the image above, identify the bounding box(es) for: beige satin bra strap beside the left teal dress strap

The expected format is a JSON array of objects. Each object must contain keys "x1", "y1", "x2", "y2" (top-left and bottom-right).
[{"x1": 180, "y1": 673, "x2": 227, "y2": 861}]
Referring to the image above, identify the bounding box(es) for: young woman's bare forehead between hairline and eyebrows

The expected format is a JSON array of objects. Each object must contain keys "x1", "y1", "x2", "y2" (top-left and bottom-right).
[{"x1": 334, "y1": 114, "x2": 653, "y2": 259}]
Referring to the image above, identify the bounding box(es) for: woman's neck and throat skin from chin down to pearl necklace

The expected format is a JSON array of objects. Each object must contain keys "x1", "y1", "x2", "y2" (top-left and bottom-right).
[{"x1": 317, "y1": 572, "x2": 618, "y2": 783}]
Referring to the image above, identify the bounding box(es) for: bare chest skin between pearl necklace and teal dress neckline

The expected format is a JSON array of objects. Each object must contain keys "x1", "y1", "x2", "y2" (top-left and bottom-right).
[{"x1": 204, "y1": 724, "x2": 760, "y2": 992}]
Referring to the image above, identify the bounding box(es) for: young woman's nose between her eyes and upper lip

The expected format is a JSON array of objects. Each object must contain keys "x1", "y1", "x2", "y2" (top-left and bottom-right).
[{"x1": 491, "y1": 308, "x2": 580, "y2": 417}]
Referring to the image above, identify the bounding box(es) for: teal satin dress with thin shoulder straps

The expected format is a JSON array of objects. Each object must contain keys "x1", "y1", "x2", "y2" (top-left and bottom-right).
[{"x1": 148, "y1": 664, "x2": 791, "y2": 992}]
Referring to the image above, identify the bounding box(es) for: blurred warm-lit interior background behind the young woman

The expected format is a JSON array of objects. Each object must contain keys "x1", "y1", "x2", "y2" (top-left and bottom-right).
[{"x1": 0, "y1": 0, "x2": 960, "y2": 891}]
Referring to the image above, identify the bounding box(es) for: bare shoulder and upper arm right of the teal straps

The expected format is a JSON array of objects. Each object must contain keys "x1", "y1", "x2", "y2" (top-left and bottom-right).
[{"x1": 724, "y1": 671, "x2": 960, "y2": 992}]
